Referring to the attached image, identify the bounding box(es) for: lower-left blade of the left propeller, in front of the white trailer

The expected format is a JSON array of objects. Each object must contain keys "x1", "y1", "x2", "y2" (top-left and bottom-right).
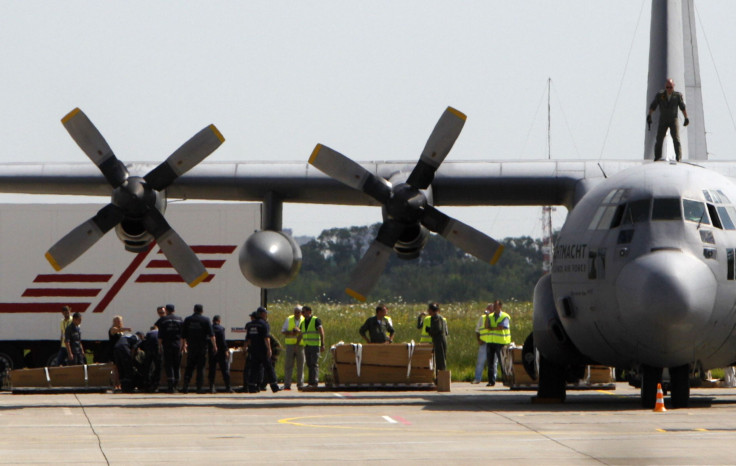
[{"x1": 46, "y1": 204, "x2": 123, "y2": 272}]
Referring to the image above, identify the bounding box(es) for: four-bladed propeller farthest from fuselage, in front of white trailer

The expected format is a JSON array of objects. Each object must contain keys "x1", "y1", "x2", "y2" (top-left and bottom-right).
[{"x1": 46, "y1": 108, "x2": 225, "y2": 287}]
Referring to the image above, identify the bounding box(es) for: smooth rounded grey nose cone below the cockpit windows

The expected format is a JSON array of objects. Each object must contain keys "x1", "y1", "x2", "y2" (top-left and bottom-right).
[{"x1": 617, "y1": 251, "x2": 717, "y2": 351}]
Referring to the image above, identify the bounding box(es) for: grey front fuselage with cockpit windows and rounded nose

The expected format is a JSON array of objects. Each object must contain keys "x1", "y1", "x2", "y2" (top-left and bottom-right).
[{"x1": 551, "y1": 162, "x2": 736, "y2": 369}]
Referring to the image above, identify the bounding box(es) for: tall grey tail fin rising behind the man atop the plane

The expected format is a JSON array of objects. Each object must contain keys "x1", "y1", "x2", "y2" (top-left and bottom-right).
[{"x1": 644, "y1": 0, "x2": 708, "y2": 160}]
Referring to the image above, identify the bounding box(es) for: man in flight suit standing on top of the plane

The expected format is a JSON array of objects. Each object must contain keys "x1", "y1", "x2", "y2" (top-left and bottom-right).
[{"x1": 647, "y1": 78, "x2": 690, "y2": 162}]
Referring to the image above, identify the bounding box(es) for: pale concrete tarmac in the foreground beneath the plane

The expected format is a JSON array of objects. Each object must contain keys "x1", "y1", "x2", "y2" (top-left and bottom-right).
[{"x1": 0, "y1": 383, "x2": 736, "y2": 466}]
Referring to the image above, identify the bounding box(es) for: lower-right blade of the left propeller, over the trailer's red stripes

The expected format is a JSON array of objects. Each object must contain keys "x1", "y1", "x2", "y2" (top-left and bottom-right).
[{"x1": 143, "y1": 209, "x2": 209, "y2": 288}]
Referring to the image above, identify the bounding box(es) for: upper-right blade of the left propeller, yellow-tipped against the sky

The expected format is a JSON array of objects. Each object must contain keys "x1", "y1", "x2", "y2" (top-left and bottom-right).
[{"x1": 143, "y1": 125, "x2": 225, "y2": 191}]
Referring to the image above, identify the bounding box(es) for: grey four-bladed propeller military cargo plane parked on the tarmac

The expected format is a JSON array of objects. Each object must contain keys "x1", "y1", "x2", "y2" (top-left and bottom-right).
[{"x1": 0, "y1": 0, "x2": 736, "y2": 407}]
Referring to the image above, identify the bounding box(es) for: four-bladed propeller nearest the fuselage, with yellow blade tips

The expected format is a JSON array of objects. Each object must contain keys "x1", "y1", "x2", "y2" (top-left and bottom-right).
[{"x1": 309, "y1": 107, "x2": 503, "y2": 301}]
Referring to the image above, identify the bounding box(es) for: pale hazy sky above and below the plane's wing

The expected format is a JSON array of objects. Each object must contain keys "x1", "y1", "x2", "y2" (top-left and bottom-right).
[{"x1": 0, "y1": 0, "x2": 736, "y2": 242}]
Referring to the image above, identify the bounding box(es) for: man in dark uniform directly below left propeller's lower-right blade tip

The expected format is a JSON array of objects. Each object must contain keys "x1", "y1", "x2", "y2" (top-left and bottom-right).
[{"x1": 182, "y1": 304, "x2": 217, "y2": 393}]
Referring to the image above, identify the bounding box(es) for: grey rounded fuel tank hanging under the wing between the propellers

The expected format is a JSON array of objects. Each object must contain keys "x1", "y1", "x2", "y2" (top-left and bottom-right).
[{"x1": 238, "y1": 230, "x2": 302, "y2": 288}]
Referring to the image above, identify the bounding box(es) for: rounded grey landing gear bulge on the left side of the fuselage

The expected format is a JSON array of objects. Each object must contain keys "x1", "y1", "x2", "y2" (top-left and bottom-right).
[{"x1": 533, "y1": 274, "x2": 591, "y2": 366}]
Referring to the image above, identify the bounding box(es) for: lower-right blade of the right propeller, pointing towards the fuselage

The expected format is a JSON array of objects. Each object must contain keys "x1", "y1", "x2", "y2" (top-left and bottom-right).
[{"x1": 422, "y1": 206, "x2": 504, "y2": 264}]
